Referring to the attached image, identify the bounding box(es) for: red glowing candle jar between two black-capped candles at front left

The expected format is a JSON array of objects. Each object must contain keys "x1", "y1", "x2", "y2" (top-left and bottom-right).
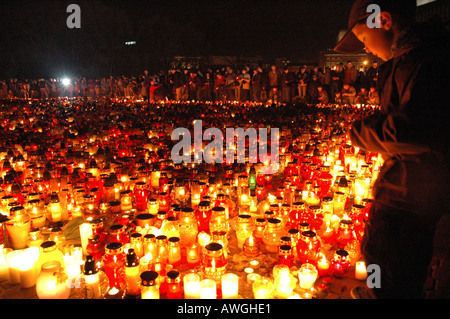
[{"x1": 101, "y1": 242, "x2": 126, "y2": 291}]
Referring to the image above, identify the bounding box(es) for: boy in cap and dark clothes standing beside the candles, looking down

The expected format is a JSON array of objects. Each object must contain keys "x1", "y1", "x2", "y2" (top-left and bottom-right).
[{"x1": 335, "y1": 0, "x2": 450, "y2": 298}]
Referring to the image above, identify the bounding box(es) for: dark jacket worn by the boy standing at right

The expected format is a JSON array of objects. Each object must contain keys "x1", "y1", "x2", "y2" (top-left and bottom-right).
[{"x1": 350, "y1": 23, "x2": 450, "y2": 219}]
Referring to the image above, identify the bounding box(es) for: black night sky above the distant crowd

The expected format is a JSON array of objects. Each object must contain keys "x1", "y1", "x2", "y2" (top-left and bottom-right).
[{"x1": 0, "y1": 0, "x2": 353, "y2": 78}]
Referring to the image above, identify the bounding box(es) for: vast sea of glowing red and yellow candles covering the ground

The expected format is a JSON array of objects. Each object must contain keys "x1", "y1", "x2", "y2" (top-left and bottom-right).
[{"x1": 0, "y1": 100, "x2": 380, "y2": 299}]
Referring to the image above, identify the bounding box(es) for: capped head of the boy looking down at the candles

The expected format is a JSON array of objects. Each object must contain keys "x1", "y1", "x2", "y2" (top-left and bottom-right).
[{"x1": 335, "y1": 0, "x2": 416, "y2": 61}]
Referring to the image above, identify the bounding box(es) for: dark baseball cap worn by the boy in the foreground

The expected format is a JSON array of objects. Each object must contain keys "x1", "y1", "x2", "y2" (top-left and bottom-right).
[{"x1": 334, "y1": 0, "x2": 416, "y2": 53}]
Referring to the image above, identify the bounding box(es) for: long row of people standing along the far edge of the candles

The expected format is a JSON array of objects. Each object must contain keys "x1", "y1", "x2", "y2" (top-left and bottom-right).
[{"x1": 0, "y1": 61, "x2": 379, "y2": 105}]
